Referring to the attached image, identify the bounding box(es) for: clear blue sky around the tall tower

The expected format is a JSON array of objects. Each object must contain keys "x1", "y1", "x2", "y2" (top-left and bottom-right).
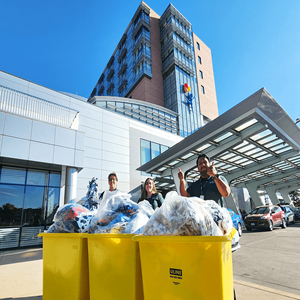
[{"x1": 0, "y1": 0, "x2": 300, "y2": 120}]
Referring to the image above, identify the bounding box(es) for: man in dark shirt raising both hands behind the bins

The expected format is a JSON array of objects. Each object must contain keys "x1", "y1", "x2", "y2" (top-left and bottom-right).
[{"x1": 178, "y1": 154, "x2": 230, "y2": 206}]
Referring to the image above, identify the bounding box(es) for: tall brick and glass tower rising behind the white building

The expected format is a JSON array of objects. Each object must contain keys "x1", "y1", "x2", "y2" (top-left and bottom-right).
[{"x1": 88, "y1": 1, "x2": 218, "y2": 137}]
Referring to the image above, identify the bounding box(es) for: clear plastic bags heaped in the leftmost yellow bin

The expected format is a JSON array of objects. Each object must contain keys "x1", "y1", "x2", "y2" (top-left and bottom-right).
[{"x1": 47, "y1": 203, "x2": 94, "y2": 233}]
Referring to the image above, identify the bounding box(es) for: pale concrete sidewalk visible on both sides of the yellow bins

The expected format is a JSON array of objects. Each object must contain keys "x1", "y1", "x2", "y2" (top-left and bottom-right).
[{"x1": 0, "y1": 248, "x2": 300, "y2": 300}]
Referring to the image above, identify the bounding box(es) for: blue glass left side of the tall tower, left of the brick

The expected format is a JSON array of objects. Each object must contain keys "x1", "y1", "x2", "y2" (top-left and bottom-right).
[{"x1": 91, "y1": 6, "x2": 152, "y2": 97}]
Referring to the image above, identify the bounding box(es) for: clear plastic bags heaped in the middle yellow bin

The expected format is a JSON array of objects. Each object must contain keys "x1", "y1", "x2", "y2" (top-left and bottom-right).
[{"x1": 89, "y1": 192, "x2": 154, "y2": 234}]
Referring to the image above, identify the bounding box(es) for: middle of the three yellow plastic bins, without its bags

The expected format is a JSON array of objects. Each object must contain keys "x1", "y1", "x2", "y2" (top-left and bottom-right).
[{"x1": 84, "y1": 233, "x2": 144, "y2": 300}]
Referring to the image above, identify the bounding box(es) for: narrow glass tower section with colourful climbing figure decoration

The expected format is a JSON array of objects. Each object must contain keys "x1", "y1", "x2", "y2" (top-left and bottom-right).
[{"x1": 160, "y1": 4, "x2": 202, "y2": 137}]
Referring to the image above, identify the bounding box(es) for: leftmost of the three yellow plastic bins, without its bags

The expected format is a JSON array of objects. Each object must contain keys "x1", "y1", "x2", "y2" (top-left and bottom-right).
[{"x1": 38, "y1": 233, "x2": 90, "y2": 300}]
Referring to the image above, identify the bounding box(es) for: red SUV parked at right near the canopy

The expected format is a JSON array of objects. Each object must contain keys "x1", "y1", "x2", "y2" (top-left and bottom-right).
[{"x1": 244, "y1": 205, "x2": 286, "y2": 231}]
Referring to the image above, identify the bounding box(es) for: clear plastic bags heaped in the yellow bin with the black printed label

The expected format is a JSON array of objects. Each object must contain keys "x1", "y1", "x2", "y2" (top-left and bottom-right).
[{"x1": 143, "y1": 192, "x2": 233, "y2": 236}]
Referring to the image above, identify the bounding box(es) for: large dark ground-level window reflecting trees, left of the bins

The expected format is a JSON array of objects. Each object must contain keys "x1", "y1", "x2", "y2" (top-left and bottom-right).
[{"x1": 0, "y1": 166, "x2": 61, "y2": 228}]
